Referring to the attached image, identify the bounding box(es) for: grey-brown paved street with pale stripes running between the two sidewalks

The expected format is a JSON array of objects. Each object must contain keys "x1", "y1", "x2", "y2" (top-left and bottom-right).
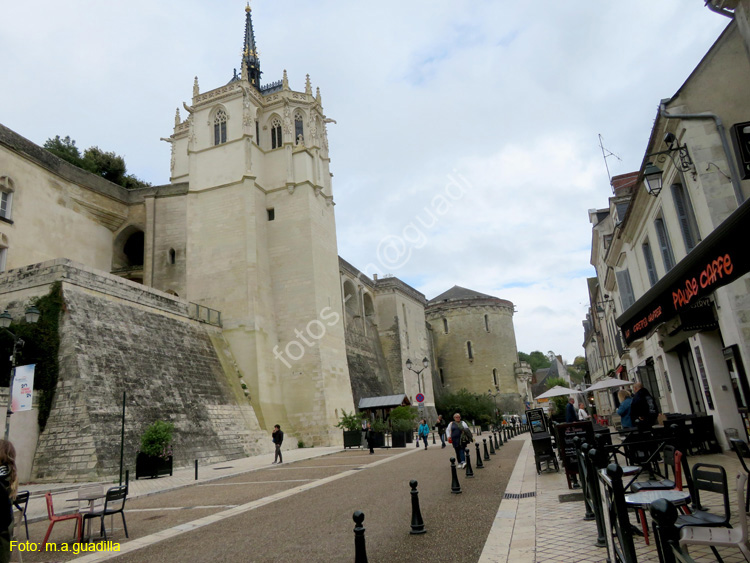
[{"x1": 16, "y1": 439, "x2": 523, "y2": 562}]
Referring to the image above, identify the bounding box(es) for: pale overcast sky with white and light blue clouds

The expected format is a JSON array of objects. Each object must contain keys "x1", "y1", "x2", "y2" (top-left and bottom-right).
[{"x1": 0, "y1": 0, "x2": 729, "y2": 362}]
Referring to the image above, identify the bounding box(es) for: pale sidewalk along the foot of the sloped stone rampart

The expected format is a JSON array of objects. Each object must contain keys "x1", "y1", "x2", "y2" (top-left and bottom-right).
[{"x1": 18, "y1": 446, "x2": 342, "y2": 523}]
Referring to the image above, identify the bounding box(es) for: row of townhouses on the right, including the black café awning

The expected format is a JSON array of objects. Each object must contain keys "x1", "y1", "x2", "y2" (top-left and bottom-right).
[{"x1": 584, "y1": 22, "x2": 750, "y2": 447}]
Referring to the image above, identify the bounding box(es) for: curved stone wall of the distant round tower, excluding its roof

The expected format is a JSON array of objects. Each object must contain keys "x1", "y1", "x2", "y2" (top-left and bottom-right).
[{"x1": 427, "y1": 305, "x2": 518, "y2": 394}]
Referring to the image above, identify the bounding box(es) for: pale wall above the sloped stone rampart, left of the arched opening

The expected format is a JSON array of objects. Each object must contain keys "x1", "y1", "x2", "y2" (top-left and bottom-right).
[{"x1": 0, "y1": 143, "x2": 128, "y2": 271}]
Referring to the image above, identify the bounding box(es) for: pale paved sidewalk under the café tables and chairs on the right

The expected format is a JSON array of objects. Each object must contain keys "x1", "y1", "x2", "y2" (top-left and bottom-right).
[{"x1": 479, "y1": 434, "x2": 744, "y2": 563}]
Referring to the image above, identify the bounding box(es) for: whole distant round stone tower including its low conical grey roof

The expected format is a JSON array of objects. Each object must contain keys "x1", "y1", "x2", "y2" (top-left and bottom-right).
[{"x1": 425, "y1": 286, "x2": 519, "y2": 399}]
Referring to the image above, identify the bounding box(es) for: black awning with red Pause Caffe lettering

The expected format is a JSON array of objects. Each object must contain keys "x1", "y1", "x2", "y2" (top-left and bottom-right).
[{"x1": 616, "y1": 200, "x2": 750, "y2": 344}]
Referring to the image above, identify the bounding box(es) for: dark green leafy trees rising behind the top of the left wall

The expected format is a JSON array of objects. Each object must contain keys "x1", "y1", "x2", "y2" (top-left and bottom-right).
[{"x1": 42, "y1": 135, "x2": 151, "y2": 190}]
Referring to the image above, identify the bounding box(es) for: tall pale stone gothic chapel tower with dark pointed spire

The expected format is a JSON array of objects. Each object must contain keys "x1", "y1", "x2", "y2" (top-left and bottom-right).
[{"x1": 166, "y1": 5, "x2": 353, "y2": 445}]
